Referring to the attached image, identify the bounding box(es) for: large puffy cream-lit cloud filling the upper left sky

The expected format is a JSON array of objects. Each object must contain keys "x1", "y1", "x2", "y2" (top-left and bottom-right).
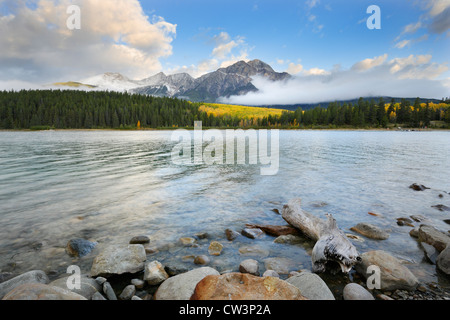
[{"x1": 0, "y1": 0, "x2": 177, "y2": 83}]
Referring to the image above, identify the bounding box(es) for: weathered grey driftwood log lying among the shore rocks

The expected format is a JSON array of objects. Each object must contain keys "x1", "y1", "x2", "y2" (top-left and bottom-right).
[{"x1": 282, "y1": 199, "x2": 361, "y2": 273}]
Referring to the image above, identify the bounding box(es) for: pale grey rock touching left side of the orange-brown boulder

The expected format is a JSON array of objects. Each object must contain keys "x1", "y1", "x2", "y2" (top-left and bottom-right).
[{"x1": 154, "y1": 267, "x2": 219, "y2": 300}]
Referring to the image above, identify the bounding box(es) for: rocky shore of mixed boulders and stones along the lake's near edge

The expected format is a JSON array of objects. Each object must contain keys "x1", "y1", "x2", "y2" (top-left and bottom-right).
[{"x1": 0, "y1": 185, "x2": 450, "y2": 300}]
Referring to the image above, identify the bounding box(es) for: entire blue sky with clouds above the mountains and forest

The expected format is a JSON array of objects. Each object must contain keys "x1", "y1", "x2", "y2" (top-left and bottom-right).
[{"x1": 0, "y1": 0, "x2": 450, "y2": 104}]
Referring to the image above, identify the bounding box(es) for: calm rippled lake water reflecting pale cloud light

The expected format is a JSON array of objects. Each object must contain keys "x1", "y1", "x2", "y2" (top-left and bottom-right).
[{"x1": 0, "y1": 131, "x2": 450, "y2": 285}]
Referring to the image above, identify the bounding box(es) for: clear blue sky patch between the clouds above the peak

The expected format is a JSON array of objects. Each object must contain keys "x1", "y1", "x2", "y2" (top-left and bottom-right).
[{"x1": 141, "y1": 0, "x2": 450, "y2": 76}]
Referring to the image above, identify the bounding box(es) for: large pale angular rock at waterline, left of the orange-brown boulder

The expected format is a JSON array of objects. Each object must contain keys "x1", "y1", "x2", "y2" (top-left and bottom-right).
[{"x1": 91, "y1": 244, "x2": 147, "y2": 277}]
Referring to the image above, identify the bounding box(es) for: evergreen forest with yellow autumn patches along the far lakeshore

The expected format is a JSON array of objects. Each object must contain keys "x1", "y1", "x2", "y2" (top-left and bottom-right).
[{"x1": 0, "y1": 90, "x2": 450, "y2": 130}]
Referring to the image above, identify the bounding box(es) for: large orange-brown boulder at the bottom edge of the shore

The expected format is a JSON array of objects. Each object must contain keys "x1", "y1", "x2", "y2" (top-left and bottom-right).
[{"x1": 191, "y1": 273, "x2": 307, "y2": 301}]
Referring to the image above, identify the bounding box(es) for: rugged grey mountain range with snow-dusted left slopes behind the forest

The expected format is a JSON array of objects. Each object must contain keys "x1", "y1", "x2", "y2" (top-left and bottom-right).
[{"x1": 58, "y1": 60, "x2": 291, "y2": 102}]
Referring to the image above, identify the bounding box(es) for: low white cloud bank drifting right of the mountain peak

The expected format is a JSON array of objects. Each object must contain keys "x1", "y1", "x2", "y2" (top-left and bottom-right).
[{"x1": 223, "y1": 55, "x2": 449, "y2": 105}]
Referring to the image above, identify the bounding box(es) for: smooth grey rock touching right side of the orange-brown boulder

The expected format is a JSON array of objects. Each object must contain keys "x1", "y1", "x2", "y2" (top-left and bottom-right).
[{"x1": 286, "y1": 272, "x2": 335, "y2": 300}]
